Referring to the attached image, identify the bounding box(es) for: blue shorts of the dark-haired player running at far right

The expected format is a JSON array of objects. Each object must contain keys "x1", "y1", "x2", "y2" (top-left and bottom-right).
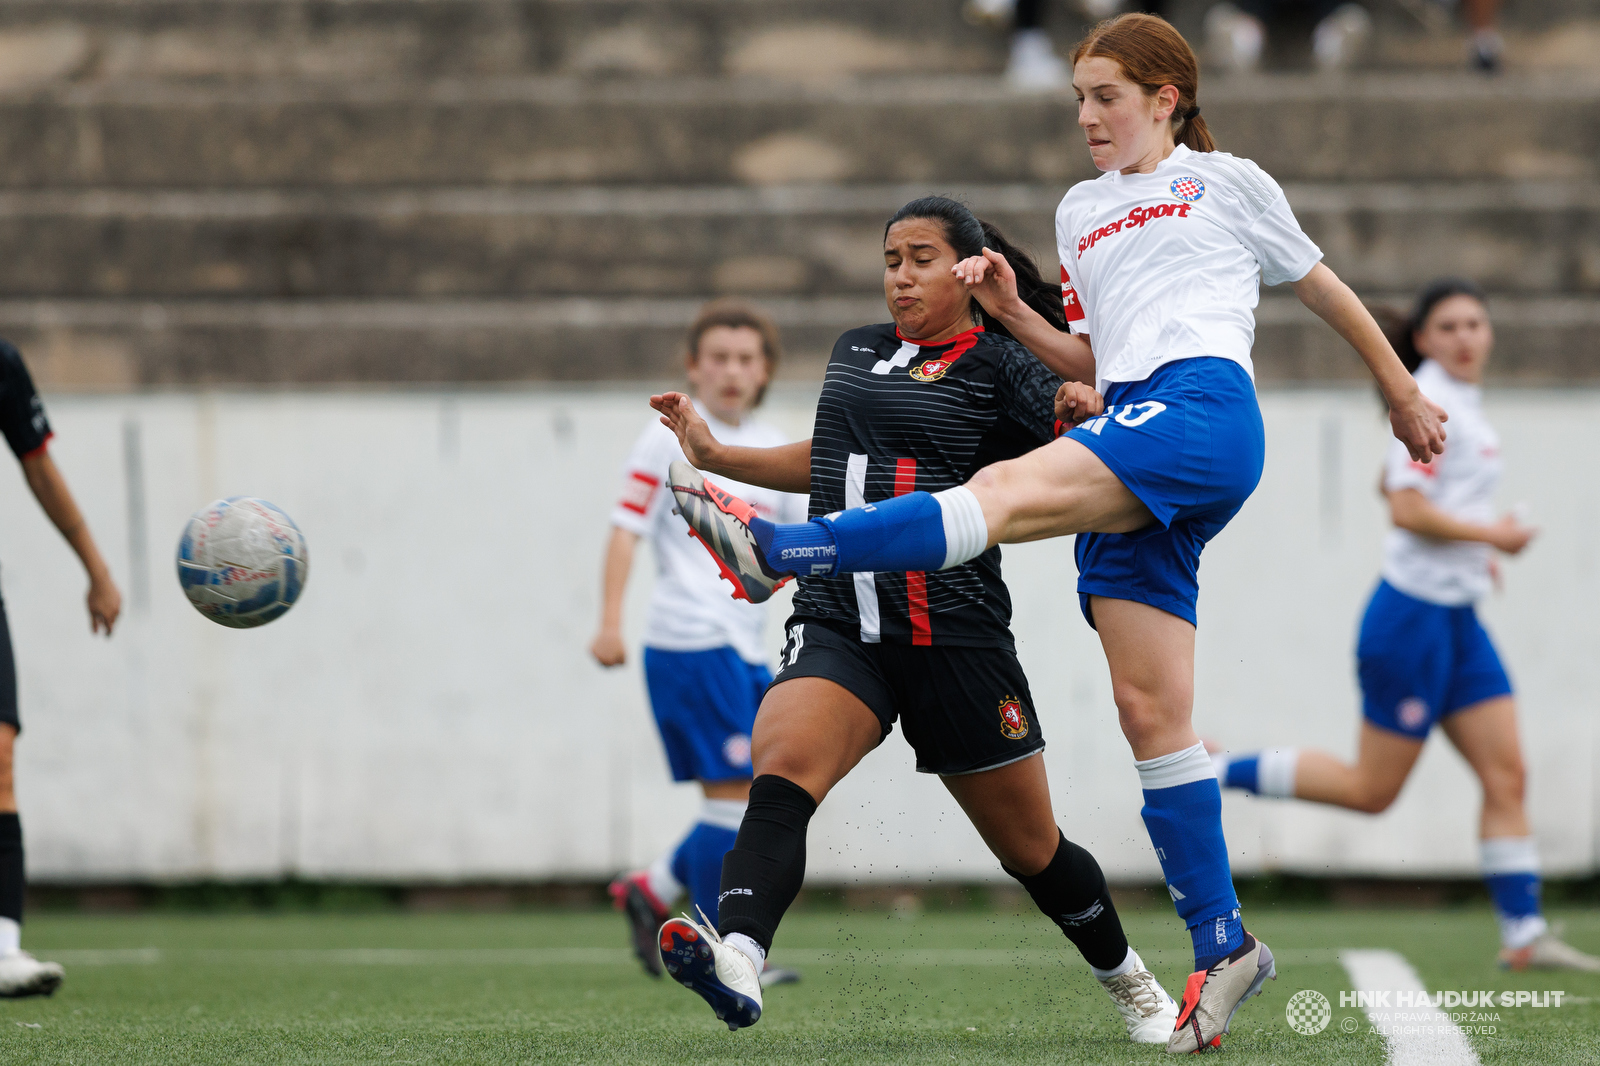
[{"x1": 1355, "y1": 581, "x2": 1512, "y2": 739}]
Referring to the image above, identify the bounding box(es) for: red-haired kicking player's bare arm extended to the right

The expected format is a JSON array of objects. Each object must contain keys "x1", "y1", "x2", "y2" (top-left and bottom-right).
[{"x1": 1294, "y1": 262, "x2": 1450, "y2": 463}]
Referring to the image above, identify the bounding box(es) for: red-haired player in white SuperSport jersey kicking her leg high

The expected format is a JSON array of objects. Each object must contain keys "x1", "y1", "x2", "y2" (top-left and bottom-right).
[{"x1": 662, "y1": 14, "x2": 1445, "y2": 1052}]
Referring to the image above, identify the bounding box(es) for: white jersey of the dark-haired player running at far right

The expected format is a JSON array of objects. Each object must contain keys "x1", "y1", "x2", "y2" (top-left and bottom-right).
[{"x1": 1384, "y1": 359, "x2": 1501, "y2": 607}]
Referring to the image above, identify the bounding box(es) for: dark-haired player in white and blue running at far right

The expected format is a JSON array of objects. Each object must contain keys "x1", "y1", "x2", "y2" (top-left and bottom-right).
[{"x1": 1213, "y1": 279, "x2": 1600, "y2": 970}]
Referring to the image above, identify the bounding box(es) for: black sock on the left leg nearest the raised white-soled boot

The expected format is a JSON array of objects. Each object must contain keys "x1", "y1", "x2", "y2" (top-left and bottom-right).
[{"x1": 717, "y1": 773, "x2": 816, "y2": 951}]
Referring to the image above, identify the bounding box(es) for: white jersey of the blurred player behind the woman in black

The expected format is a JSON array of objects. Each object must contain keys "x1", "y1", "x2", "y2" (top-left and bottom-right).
[{"x1": 611, "y1": 403, "x2": 806, "y2": 663}]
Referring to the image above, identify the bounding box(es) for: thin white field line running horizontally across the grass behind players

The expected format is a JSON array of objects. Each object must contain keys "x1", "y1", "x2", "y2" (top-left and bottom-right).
[{"x1": 42, "y1": 944, "x2": 1339, "y2": 968}]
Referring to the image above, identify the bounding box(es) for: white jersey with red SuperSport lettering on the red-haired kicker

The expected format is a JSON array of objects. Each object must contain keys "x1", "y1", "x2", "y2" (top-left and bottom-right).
[{"x1": 1056, "y1": 144, "x2": 1322, "y2": 392}]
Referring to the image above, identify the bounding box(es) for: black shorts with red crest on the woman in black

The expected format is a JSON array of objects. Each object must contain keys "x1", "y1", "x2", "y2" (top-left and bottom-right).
[{"x1": 773, "y1": 619, "x2": 1045, "y2": 776}]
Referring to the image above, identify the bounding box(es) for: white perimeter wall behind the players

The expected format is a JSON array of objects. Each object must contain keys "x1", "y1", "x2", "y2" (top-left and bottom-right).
[{"x1": 0, "y1": 391, "x2": 1600, "y2": 882}]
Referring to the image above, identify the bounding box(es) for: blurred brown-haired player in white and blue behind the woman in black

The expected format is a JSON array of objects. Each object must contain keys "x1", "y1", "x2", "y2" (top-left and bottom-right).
[{"x1": 590, "y1": 301, "x2": 805, "y2": 983}]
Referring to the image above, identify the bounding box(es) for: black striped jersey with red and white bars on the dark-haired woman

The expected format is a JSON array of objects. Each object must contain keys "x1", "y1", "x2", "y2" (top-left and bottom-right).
[{"x1": 794, "y1": 325, "x2": 1061, "y2": 648}]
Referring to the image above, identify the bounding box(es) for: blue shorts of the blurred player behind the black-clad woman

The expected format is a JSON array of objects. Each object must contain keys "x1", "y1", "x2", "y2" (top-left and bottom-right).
[{"x1": 645, "y1": 647, "x2": 773, "y2": 781}]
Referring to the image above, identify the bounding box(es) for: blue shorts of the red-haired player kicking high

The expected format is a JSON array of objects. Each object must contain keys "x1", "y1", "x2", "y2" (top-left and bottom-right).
[{"x1": 1067, "y1": 357, "x2": 1266, "y2": 626}]
